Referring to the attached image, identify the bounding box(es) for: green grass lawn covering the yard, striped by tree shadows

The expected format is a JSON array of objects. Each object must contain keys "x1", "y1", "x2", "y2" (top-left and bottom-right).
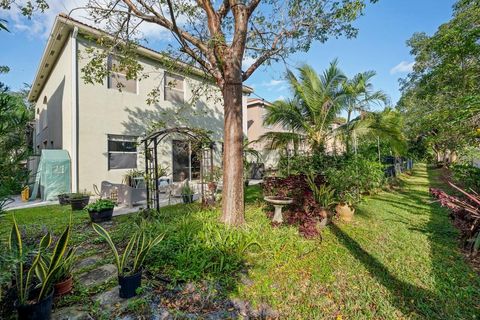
[{"x1": 0, "y1": 165, "x2": 480, "y2": 319}]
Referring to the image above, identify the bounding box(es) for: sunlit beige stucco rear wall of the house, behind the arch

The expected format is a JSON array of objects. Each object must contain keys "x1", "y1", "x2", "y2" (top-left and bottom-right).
[{"x1": 78, "y1": 37, "x2": 223, "y2": 191}]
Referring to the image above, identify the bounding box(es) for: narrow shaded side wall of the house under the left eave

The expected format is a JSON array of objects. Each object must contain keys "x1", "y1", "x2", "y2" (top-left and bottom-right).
[{"x1": 34, "y1": 39, "x2": 72, "y2": 153}]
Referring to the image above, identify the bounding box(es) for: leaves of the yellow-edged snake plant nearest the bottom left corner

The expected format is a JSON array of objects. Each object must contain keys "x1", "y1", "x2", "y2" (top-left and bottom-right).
[{"x1": 8, "y1": 216, "x2": 73, "y2": 305}]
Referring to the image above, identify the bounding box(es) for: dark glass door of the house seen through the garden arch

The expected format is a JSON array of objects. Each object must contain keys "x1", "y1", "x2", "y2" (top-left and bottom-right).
[{"x1": 172, "y1": 140, "x2": 200, "y2": 182}]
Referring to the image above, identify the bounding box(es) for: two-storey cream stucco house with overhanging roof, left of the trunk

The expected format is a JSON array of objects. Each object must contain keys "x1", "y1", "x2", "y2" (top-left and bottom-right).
[{"x1": 28, "y1": 14, "x2": 252, "y2": 192}]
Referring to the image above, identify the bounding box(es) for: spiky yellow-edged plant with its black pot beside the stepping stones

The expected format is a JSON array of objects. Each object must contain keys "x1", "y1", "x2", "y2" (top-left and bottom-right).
[{"x1": 93, "y1": 221, "x2": 164, "y2": 299}]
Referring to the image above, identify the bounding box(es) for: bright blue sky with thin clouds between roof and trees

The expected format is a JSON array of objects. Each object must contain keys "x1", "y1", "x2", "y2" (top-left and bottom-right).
[{"x1": 0, "y1": 0, "x2": 455, "y2": 109}]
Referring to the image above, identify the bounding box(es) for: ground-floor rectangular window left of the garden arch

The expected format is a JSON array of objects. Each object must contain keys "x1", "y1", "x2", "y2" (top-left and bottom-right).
[{"x1": 108, "y1": 134, "x2": 137, "y2": 170}]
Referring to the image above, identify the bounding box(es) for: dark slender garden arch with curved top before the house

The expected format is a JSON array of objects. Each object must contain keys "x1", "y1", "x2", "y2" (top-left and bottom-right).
[{"x1": 140, "y1": 127, "x2": 215, "y2": 211}]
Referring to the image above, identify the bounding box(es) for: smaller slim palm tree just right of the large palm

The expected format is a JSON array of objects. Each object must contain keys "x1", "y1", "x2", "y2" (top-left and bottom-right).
[{"x1": 342, "y1": 71, "x2": 388, "y2": 152}]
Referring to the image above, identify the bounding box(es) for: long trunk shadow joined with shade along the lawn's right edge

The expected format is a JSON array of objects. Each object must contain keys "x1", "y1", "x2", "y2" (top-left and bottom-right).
[{"x1": 330, "y1": 166, "x2": 480, "y2": 319}]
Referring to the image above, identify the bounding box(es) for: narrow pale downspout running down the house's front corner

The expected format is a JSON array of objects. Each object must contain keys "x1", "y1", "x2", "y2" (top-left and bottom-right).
[{"x1": 71, "y1": 27, "x2": 78, "y2": 192}]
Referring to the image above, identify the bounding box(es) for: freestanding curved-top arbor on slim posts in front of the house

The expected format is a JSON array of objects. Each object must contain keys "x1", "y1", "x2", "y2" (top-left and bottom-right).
[{"x1": 141, "y1": 127, "x2": 215, "y2": 211}]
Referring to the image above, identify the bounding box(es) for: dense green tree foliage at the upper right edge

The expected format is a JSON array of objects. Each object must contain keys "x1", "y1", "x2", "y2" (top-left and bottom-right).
[{"x1": 397, "y1": 0, "x2": 480, "y2": 161}]
